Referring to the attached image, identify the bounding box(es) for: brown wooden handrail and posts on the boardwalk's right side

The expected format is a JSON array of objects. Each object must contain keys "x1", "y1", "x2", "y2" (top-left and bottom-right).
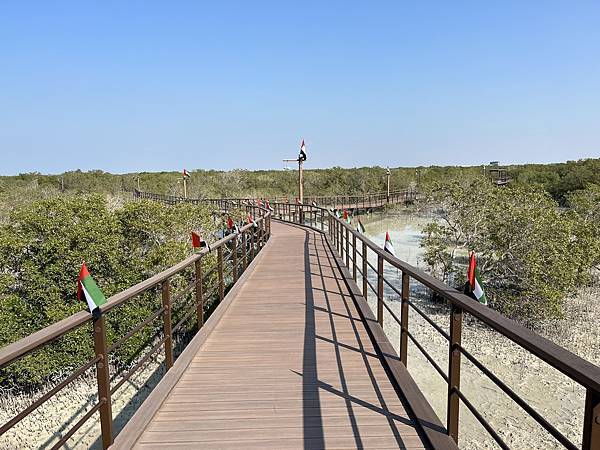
[{"x1": 274, "y1": 204, "x2": 600, "y2": 450}]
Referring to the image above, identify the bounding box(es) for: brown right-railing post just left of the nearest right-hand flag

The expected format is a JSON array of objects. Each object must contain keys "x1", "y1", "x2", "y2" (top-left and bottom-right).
[{"x1": 446, "y1": 305, "x2": 462, "y2": 443}]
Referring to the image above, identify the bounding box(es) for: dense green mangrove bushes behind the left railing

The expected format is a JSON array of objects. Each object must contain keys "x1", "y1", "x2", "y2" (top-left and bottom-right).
[{"x1": 0, "y1": 195, "x2": 216, "y2": 386}]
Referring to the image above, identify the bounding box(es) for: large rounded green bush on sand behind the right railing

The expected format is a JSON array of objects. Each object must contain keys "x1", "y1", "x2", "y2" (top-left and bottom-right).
[{"x1": 422, "y1": 179, "x2": 597, "y2": 321}]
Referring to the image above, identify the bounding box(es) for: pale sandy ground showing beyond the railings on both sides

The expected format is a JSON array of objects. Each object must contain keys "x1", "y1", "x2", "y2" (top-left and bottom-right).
[{"x1": 0, "y1": 215, "x2": 600, "y2": 450}]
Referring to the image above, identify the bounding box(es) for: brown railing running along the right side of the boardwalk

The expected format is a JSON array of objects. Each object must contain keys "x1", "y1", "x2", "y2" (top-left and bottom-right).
[{"x1": 273, "y1": 204, "x2": 600, "y2": 450}]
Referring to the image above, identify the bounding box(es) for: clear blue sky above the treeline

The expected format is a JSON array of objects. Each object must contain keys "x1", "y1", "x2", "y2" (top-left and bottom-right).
[{"x1": 0, "y1": 0, "x2": 600, "y2": 174}]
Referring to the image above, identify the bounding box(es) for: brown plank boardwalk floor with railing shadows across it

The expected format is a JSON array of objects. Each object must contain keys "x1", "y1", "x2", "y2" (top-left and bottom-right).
[{"x1": 115, "y1": 223, "x2": 424, "y2": 449}]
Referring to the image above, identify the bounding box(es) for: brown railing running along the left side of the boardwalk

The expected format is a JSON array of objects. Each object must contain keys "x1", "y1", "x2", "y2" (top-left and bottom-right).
[{"x1": 0, "y1": 206, "x2": 271, "y2": 449}]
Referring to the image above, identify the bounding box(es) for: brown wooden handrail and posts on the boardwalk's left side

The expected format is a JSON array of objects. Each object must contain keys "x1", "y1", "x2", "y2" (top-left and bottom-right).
[{"x1": 0, "y1": 201, "x2": 271, "y2": 448}]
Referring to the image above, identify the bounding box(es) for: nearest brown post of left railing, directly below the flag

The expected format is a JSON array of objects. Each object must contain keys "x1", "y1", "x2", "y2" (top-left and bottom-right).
[{"x1": 93, "y1": 315, "x2": 113, "y2": 449}]
